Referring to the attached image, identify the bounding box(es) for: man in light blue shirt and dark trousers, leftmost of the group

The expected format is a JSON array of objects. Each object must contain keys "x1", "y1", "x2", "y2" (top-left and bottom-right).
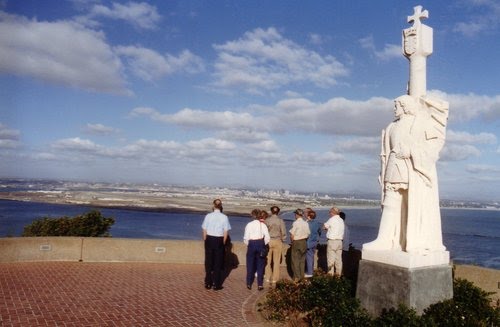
[{"x1": 201, "y1": 199, "x2": 231, "y2": 291}]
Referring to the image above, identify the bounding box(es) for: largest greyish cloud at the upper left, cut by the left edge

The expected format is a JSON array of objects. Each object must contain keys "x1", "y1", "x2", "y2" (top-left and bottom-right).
[{"x1": 0, "y1": 12, "x2": 130, "y2": 94}]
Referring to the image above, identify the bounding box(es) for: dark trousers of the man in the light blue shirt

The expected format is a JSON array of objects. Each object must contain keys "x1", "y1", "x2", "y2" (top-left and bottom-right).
[{"x1": 205, "y1": 235, "x2": 224, "y2": 287}]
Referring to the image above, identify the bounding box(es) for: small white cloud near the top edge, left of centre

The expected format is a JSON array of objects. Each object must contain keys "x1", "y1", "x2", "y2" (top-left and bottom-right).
[{"x1": 89, "y1": 2, "x2": 161, "y2": 29}]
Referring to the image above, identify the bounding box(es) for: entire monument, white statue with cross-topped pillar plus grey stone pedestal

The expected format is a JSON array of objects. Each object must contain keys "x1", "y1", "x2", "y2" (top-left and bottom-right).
[{"x1": 356, "y1": 6, "x2": 453, "y2": 316}]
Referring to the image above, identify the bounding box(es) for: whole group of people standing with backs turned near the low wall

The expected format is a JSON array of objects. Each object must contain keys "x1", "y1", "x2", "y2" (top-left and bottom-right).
[{"x1": 202, "y1": 199, "x2": 346, "y2": 290}]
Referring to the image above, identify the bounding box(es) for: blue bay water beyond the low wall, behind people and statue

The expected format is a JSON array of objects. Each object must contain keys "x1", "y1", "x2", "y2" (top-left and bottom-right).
[{"x1": 0, "y1": 200, "x2": 500, "y2": 269}]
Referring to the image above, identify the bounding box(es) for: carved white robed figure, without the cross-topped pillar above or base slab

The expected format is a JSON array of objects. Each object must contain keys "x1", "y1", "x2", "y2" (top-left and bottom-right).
[{"x1": 363, "y1": 95, "x2": 448, "y2": 254}]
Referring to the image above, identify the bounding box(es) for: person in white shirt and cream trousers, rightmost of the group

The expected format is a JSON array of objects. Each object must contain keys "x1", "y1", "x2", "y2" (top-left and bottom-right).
[{"x1": 323, "y1": 207, "x2": 345, "y2": 276}]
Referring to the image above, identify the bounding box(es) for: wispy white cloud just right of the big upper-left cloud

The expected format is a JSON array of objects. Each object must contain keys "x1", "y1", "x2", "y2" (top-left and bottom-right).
[{"x1": 114, "y1": 46, "x2": 204, "y2": 81}]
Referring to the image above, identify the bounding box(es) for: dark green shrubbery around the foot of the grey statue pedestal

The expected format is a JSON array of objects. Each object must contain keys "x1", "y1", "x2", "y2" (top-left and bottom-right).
[{"x1": 260, "y1": 273, "x2": 500, "y2": 327}]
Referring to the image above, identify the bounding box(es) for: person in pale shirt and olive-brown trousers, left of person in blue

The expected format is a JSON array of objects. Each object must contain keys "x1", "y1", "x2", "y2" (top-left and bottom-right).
[{"x1": 290, "y1": 209, "x2": 311, "y2": 281}]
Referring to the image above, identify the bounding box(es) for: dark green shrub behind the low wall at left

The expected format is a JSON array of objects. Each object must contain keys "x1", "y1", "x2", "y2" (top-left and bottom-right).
[{"x1": 22, "y1": 210, "x2": 115, "y2": 237}]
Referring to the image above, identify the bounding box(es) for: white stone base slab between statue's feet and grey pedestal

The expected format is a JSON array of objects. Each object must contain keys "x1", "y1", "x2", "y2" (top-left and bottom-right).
[{"x1": 361, "y1": 250, "x2": 450, "y2": 268}]
